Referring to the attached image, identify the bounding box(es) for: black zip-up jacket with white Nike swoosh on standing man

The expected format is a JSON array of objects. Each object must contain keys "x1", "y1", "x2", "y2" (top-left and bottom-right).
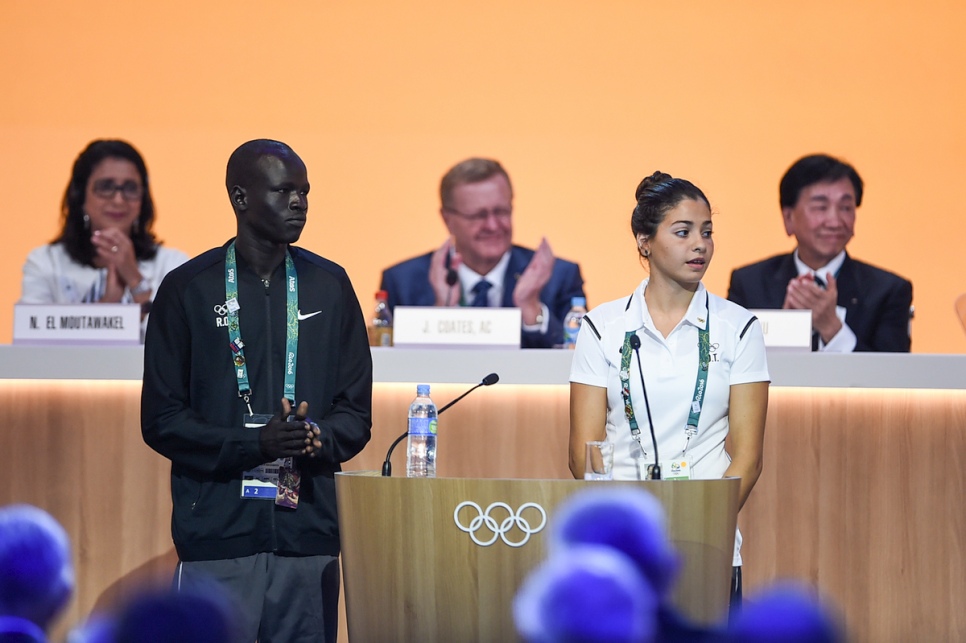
[{"x1": 141, "y1": 244, "x2": 372, "y2": 561}]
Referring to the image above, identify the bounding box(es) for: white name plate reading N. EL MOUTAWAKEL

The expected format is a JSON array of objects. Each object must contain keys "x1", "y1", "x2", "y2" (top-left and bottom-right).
[{"x1": 13, "y1": 304, "x2": 141, "y2": 345}]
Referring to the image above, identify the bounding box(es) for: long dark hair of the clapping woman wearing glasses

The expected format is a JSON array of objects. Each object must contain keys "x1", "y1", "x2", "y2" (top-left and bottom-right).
[{"x1": 53, "y1": 140, "x2": 158, "y2": 266}]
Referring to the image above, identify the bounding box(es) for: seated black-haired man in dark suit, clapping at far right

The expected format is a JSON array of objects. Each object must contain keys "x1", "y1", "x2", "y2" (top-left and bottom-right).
[{"x1": 728, "y1": 154, "x2": 912, "y2": 353}]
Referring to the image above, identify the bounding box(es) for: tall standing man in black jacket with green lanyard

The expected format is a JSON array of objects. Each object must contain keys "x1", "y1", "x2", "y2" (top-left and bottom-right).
[{"x1": 141, "y1": 140, "x2": 372, "y2": 643}]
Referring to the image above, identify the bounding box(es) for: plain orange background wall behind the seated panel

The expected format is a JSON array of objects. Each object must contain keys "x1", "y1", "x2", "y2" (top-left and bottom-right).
[{"x1": 0, "y1": 0, "x2": 966, "y2": 353}]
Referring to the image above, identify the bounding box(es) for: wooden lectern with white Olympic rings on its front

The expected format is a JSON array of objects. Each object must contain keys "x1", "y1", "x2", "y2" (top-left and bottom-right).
[{"x1": 336, "y1": 471, "x2": 739, "y2": 643}]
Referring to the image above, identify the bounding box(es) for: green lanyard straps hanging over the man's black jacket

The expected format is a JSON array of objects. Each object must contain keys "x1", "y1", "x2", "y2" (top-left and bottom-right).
[{"x1": 225, "y1": 241, "x2": 299, "y2": 413}]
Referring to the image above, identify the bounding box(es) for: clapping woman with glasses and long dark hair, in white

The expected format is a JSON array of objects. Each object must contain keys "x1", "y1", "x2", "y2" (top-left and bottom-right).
[{"x1": 19, "y1": 140, "x2": 188, "y2": 318}]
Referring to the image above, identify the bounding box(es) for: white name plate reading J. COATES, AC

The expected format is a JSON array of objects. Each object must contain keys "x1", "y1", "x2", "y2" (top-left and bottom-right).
[{"x1": 392, "y1": 306, "x2": 522, "y2": 348}]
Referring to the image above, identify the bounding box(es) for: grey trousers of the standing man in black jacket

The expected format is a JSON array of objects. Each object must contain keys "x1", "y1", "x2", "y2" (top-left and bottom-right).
[{"x1": 174, "y1": 553, "x2": 339, "y2": 643}]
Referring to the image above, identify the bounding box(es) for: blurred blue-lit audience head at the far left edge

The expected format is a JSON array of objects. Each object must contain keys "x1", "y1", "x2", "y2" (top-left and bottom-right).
[{"x1": 0, "y1": 505, "x2": 74, "y2": 630}]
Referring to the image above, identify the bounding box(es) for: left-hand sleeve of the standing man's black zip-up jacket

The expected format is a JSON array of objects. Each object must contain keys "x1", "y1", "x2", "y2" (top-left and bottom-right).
[{"x1": 141, "y1": 278, "x2": 267, "y2": 476}]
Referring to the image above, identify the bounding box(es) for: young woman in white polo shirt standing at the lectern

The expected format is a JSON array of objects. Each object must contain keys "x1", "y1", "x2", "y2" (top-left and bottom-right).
[{"x1": 570, "y1": 172, "x2": 769, "y2": 600}]
